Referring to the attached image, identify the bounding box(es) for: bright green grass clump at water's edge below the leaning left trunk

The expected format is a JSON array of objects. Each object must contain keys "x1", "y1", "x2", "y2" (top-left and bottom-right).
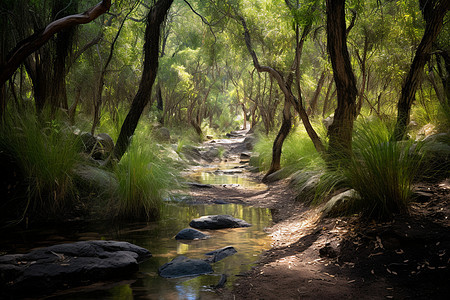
[{"x1": 114, "y1": 133, "x2": 178, "y2": 220}]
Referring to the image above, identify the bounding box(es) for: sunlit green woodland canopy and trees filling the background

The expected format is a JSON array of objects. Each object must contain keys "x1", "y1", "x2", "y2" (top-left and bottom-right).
[{"x1": 1, "y1": 0, "x2": 449, "y2": 162}]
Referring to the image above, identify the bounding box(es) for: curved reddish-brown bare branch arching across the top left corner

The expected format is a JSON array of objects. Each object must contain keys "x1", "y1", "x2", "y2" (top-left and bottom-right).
[{"x1": 0, "y1": 0, "x2": 111, "y2": 116}]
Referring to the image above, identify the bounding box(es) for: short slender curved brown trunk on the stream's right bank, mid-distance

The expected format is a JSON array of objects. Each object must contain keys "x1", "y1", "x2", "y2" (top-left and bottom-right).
[{"x1": 262, "y1": 100, "x2": 292, "y2": 182}]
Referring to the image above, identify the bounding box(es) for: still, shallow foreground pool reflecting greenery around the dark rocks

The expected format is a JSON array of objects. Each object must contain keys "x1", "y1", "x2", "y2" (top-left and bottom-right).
[{"x1": 3, "y1": 202, "x2": 272, "y2": 299}]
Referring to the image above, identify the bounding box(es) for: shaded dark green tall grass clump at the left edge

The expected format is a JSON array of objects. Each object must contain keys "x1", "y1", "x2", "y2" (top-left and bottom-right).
[{"x1": 0, "y1": 111, "x2": 81, "y2": 218}]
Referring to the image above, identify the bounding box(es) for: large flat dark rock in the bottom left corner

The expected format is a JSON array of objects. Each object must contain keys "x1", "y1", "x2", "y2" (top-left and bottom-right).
[{"x1": 0, "y1": 241, "x2": 151, "y2": 298}]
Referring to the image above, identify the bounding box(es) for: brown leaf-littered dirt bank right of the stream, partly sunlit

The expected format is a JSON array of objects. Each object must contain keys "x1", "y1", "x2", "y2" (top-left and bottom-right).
[{"x1": 191, "y1": 131, "x2": 450, "y2": 299}]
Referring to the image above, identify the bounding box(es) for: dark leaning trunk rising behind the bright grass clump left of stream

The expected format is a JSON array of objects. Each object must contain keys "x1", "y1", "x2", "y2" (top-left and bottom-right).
[{"x1": 114, "y1": 0, "x2": 173, "y2": 160}]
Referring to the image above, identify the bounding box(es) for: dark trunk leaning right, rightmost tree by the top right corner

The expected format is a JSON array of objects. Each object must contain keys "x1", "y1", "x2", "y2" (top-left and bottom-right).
[{"x1": 393, "y1": 0, "x2": 450, "y2": 141}]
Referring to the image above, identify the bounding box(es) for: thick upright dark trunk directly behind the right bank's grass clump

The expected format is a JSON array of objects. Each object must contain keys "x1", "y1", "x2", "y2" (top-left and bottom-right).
[{"x1": 327, "y1": 0, "x2": 357, "y2": 160}]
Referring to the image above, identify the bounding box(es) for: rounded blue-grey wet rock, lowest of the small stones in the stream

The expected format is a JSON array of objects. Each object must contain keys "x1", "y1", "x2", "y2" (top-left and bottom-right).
[{"x1": 158, "y1": 256, "x2": 213, "y2": 278}]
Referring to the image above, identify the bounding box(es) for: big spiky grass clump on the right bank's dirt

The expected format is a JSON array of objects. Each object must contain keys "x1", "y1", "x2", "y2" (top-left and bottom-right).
[{"x1": 344, "y1": 118, "x2": 424, "y2": 219}]
